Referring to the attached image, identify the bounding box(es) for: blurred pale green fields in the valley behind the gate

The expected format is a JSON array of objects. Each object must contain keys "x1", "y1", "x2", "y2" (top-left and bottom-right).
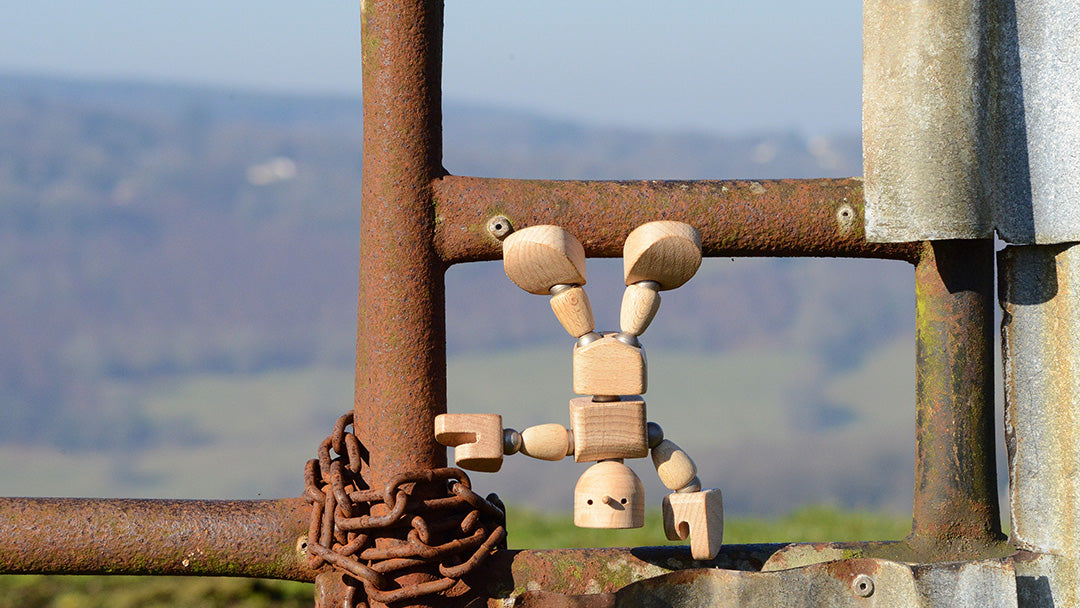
[{"x1": 0, "y1": 340, "x2": 914, "y2": 515}]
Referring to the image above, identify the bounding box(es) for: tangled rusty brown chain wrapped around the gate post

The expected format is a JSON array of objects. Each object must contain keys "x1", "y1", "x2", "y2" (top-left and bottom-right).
[{"x1": 303, "y1": 413, "x2": 507, "y2": 606}]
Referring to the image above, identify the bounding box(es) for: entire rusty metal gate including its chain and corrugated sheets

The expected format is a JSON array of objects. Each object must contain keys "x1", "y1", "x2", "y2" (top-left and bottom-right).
[{"x1": 0, "y1": 0, "x2": 1080, "y2": 607}]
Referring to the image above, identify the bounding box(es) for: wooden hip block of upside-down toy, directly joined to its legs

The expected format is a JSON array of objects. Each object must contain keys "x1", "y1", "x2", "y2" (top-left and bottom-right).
[{"x1": 573, "y1": 334, "x2": 648, "y2": 395}]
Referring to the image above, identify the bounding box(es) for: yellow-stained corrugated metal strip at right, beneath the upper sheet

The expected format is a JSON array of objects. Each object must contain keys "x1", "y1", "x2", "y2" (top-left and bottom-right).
[{"x1": 999, "y1": 245, "x2": 1080, "y2": 556}]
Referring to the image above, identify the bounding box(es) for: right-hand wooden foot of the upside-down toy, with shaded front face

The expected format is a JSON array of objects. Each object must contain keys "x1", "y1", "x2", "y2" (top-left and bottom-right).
[{"x1": 622, "y1": 221, "x2": 701, "y2": 291}]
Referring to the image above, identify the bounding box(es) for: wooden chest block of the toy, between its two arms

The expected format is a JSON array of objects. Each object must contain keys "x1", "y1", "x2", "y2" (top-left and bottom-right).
[{"x1": 570, "y1": 397, "x2": 649, "y2": 462}]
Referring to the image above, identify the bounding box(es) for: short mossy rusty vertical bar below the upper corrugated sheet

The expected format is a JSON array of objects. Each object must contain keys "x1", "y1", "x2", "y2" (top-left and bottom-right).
[{"x1": 910, "y1": 239, "x2": 1001, "y2": 550}]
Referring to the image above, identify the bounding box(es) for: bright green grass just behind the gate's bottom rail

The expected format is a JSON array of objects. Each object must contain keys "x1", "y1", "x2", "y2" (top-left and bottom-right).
[{"x1": 0, "y1": 506, "x2": 910, "y2": 608}]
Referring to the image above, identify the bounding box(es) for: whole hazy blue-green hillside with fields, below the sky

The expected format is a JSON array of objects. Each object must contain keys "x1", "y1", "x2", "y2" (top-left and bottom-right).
[{"x1": 0, "y1": 76, "x2": 914, "y2": 512}]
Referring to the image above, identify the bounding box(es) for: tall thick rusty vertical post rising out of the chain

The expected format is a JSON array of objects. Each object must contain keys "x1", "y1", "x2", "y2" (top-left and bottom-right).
[{"x1": 353, "y1": 0, "x2": 446, "y2": 604}]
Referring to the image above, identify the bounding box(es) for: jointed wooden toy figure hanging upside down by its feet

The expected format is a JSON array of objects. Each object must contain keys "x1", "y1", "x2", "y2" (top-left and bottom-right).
[{"x1": 435, "y1": 221, "x2": 724, "y2": 559}]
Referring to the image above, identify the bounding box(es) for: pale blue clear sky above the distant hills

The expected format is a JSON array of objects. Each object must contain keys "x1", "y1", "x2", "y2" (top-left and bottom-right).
[{"x1": 0, "y1": 0, "x2": 861, "y2": 134}]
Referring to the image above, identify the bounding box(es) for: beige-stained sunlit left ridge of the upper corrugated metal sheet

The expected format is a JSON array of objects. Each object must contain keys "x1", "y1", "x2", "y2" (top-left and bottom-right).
[{"x1": 863, "y1": 0, "x2": 994, "y2": 242}]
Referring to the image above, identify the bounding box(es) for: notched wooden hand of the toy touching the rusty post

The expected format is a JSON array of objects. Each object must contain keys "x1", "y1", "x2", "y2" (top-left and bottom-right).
[{"x1": 435, "y1": 414, "x2": 502, "y2": 473}]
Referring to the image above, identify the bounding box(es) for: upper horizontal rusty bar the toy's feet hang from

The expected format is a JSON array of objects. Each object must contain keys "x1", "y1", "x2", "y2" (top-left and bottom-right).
[{"x1": 433, "y1": 176, "x2": 919, "y2": 264}]
